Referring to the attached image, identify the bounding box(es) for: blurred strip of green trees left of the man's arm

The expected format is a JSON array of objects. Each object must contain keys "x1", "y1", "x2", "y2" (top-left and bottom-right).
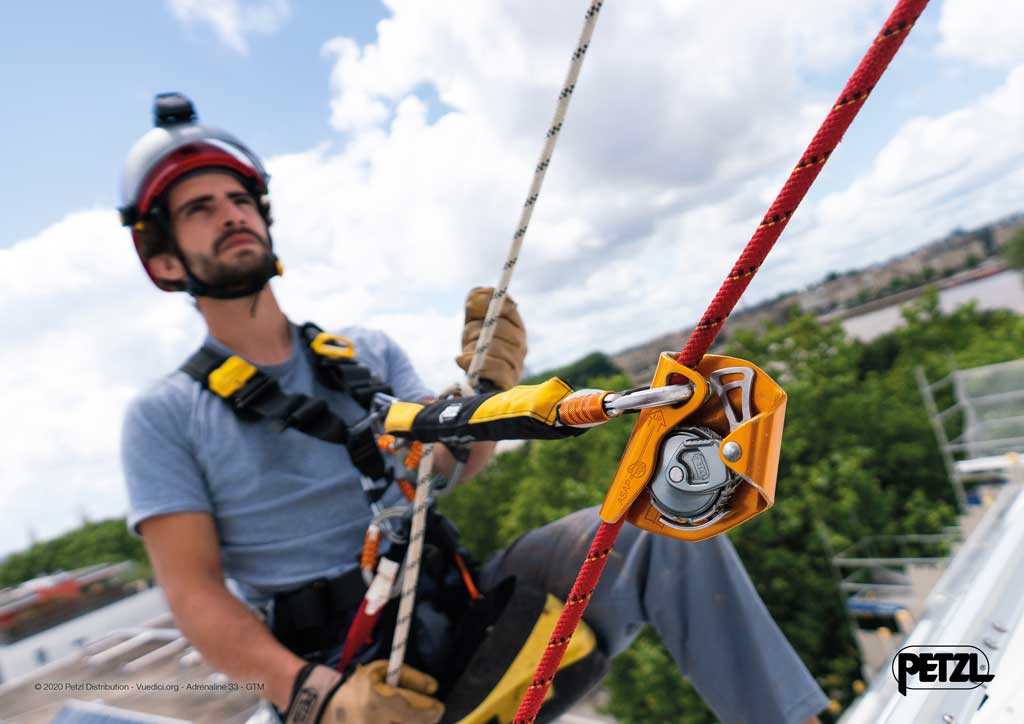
[{"x1": 0, "y1": 518, "x2": 148, "y2": 587}]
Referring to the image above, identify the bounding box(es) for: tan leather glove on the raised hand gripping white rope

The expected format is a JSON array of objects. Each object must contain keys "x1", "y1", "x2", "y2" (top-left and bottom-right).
[{"x1": 455, "y1": 287, "x2": 526, "y2": 390}]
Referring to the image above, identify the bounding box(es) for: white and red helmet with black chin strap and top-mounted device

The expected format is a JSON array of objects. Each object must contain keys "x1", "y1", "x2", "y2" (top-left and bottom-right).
[{"x1": 119, "y1": 93, "x2": 281, "y2": 299}]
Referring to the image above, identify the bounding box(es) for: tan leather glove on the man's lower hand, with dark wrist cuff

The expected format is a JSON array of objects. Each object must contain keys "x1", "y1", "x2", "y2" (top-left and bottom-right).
[{"x1": 285, "y1": 658, "x2": 444, "y2": 724}]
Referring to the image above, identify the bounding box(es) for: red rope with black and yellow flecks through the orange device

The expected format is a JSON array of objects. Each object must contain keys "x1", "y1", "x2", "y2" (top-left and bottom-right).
[{"x1": 512, "y1": 0, "x2": 928, "y2": 724}]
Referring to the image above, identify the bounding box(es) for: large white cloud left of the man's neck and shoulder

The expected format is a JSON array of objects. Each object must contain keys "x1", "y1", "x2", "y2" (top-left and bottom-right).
[{"x1": 0, "y1": 211, "x2": 202, "y2": 555}]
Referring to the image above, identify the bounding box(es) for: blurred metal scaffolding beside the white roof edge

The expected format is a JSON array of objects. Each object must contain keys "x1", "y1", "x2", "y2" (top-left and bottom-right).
[{"x1": 829, "y1": 358, "x2": 1024, "y2": 679}]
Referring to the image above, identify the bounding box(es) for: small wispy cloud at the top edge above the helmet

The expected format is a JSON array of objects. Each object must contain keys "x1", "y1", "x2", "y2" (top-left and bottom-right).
[{"x1": 168, "y1": 0, "x2": 292, "y2": 53}]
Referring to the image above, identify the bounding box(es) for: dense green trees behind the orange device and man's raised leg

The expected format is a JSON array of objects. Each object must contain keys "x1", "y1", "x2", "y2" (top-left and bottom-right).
[{"x1": 442, "y1": 290, "x2": 1024, "y2": 724}]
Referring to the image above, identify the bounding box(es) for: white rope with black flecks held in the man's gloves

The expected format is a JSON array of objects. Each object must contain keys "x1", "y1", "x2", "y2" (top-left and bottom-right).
[{"x1": 387, "y1": 0, "x2": 604, "y2": 686}]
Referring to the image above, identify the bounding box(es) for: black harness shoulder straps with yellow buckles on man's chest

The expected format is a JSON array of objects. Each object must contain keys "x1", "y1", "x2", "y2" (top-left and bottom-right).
[{"x1": 180, "y1": 322, "x2": 391, "y2": 480}]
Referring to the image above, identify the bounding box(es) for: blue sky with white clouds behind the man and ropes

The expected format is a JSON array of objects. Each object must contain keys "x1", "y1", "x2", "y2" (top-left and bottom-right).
[{"x1": 0, "y1": 0, "x2": 1024, "y2": 555}]
